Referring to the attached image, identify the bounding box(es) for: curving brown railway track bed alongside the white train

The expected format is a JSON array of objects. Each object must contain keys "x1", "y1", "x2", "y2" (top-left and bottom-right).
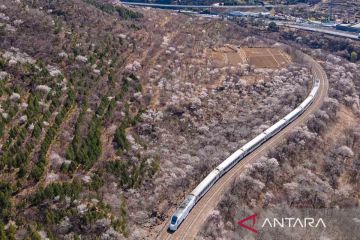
[{"x1": 157, "y1": 53, "x2": 328, "y2": 240}]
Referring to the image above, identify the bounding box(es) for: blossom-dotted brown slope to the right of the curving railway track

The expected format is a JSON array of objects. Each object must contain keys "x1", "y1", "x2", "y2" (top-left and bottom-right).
[{"x1": 197, "y1": 18, "x2": 360, "y2": 239}]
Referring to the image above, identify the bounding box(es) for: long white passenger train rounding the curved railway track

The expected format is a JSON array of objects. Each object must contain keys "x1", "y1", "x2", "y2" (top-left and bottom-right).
[{"x1": 169, "y1": 79, "x2": 320, "y2": 231}]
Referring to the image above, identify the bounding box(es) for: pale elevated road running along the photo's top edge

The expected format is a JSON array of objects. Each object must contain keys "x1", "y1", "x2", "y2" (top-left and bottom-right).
[{"x1": 120, "y1": 1, "x2": 301, "y2": 9}]
